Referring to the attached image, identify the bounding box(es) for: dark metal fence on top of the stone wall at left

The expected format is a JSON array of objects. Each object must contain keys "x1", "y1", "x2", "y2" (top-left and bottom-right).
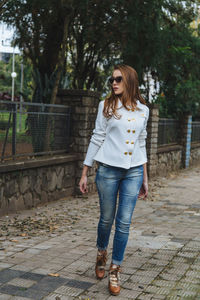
[{"x1": 0, "y1": 100, "x2": 70, "y2": 161}]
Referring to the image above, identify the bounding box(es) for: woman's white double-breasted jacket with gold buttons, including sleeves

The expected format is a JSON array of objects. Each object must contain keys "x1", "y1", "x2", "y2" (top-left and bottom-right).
[{"x1": 83, "y1": 100, "x2": 149, "y2": 169}]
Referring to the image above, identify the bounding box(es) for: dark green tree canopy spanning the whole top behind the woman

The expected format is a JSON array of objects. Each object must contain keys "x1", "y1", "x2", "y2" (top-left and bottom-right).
[{"x1": 2, "y1": 0, "x2": 200, "y2": 117}]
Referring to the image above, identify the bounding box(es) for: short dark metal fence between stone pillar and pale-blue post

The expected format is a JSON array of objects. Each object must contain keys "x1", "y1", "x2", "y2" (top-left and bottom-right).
[{"x1": 158, "y1": 118, "x2": 180, "y2": 146}]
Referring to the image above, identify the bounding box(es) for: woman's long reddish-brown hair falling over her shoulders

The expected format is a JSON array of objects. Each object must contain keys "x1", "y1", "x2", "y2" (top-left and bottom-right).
[{"x1": 103, "y1": 65, "x2": 146, "y2": 119}]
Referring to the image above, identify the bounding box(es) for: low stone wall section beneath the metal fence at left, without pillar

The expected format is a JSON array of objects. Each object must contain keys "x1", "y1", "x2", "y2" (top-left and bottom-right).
[{"x1": 0, "y1": 155, "x2": 76, "y2": 214}]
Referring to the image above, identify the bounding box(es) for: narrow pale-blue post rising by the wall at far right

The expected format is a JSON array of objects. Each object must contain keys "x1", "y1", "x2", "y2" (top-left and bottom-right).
[{"x1": 181, "y1": 115, "x2": 192, "y2": 168}]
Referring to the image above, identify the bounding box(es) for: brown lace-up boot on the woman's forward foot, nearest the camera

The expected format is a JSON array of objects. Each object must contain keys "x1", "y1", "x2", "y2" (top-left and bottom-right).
[{"x1": 108, "y1": 264, "x2": 121, "y2": 296}]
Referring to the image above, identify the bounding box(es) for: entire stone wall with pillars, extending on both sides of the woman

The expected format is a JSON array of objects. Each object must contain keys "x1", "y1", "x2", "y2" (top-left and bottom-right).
[{"x1": 0, "y1": 90, "x2": 200, "y2": 214}]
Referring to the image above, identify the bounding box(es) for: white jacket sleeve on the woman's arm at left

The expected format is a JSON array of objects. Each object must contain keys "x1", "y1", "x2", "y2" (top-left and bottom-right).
[{"x1": 83, "y1": 101, "x2": 107, "y2": 167}]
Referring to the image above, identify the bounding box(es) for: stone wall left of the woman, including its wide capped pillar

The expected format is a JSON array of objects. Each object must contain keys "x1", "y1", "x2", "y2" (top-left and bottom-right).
[{"x1": 0, "y1": 90, "x2": 100, "y2": 214}]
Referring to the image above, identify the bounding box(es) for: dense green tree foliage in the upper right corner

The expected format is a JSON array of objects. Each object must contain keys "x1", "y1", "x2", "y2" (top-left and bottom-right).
[{"x1": 156, "y1": 1, "x2": 200, "y2": 118}]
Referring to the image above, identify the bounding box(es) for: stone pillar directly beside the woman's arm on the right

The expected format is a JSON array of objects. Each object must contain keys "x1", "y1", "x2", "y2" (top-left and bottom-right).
[{"x1": 147, "y1": 103, "x2": 159, "y2": 177}]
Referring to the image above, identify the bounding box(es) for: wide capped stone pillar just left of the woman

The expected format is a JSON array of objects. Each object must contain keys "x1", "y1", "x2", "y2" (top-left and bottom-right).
[{"x1": 57, "y1": 90, "x2": 100, "y2": 194}]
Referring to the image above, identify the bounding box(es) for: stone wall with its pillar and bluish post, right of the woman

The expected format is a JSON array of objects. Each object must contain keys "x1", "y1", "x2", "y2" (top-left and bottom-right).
[{"x1": 147, "y1": 104, "x2": 200, "y2": 178}]
